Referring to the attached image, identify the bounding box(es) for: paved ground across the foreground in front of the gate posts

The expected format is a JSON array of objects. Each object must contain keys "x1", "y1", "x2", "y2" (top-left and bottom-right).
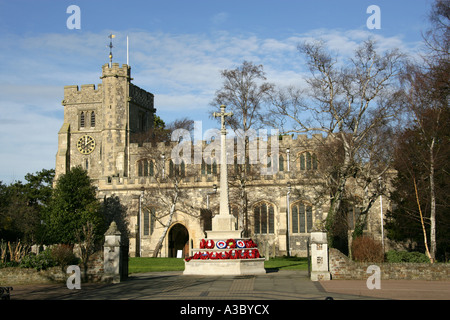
[{"x1": 7, "y1": 271, "x2": 450, "y2": 300}]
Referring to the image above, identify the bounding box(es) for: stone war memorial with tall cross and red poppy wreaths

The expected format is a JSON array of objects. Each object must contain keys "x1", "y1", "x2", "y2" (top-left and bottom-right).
[{"x1": 183, "y1": 105, "x2": 266, "y2": 276}]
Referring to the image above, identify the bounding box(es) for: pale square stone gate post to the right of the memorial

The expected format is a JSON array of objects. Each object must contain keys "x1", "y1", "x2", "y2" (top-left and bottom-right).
[{"x1": 310, "y1": 231, "x2": 331, "y2": 281}]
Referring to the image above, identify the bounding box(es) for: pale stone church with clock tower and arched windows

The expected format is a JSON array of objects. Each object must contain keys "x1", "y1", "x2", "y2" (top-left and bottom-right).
[{"x1": 55, "y1": 63, "x2": 388, "y2": 257}]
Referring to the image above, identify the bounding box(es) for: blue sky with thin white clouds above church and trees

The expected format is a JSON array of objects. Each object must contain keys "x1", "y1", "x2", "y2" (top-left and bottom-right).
[{"x1": 0, "y1": 0, "x2": 432, "y2": 184}]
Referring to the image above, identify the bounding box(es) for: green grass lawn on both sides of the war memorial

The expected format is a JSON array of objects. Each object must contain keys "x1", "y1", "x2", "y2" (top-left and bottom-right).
[{"x1": 128, "y1": 257, "x2": 308, "y2": 273}]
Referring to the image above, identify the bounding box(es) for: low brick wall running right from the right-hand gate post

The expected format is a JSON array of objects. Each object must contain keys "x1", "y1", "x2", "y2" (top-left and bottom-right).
[{"x1": 329, "y1": 248, "x2": 450, "y2": 281}]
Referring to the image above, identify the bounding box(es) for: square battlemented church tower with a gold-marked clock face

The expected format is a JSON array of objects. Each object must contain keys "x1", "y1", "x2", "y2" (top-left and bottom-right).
[{"x1": 56, "y1": 63, "x2": 155, "y2": 180}]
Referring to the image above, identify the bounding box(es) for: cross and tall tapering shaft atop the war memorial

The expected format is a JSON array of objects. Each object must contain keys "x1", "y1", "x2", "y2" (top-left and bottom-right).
[{"x1": 213, "y1": 105, "x2": 233, "y2": 216}]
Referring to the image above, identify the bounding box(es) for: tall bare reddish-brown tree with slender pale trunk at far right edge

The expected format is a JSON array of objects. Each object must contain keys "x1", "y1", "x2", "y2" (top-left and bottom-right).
[{"x1": 392, "y1": 0, "x2": 450, "y2": 261}]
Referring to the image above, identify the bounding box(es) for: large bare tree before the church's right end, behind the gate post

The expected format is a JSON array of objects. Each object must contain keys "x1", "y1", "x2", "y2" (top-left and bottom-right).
[{"x1": 271, "y1": 39, "x2": 403, "y2": 245}]
